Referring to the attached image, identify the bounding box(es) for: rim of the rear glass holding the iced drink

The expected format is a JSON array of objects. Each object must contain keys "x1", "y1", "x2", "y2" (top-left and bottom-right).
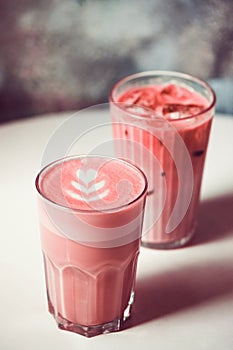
[{"x1": 109, "y1": 70, "x2": 216, "y2": 123}]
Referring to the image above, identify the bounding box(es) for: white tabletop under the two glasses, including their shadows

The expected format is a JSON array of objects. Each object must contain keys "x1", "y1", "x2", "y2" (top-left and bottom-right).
[{"x1": 0, "y1": 114, "x2": 233, "y2": 350}]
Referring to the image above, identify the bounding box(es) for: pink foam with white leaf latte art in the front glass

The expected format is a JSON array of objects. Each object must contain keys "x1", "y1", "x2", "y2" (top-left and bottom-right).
[{"x1": 40, "y1": 157, "x2": 144, "y2": 210}]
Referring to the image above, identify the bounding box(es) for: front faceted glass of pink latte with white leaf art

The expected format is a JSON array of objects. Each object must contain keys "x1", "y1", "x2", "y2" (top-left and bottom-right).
[{"x1": 36, "y1": 156, "x2": 147, "y2": 337}]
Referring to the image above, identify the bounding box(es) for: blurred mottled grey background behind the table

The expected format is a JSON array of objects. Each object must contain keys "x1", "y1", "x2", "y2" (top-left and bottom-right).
[{"x1": 0, "y1": 0, "x2": 233, "y2": 123}]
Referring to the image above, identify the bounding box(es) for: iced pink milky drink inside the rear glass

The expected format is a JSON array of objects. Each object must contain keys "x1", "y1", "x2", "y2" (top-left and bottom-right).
[{"x1": 112, "y1": 83, "x2": 213, "y2": 248}]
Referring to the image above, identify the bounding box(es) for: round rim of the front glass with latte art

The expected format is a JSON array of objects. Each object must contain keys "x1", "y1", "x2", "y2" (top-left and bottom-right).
[{"x1": 35, "y1": 154, "x2": 148, "y2": 214}]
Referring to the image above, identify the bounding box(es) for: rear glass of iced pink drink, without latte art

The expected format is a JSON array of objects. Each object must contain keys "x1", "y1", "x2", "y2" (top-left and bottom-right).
[{"x1": 110, "y1": 71, "x2": 216, "y2": 249}]
